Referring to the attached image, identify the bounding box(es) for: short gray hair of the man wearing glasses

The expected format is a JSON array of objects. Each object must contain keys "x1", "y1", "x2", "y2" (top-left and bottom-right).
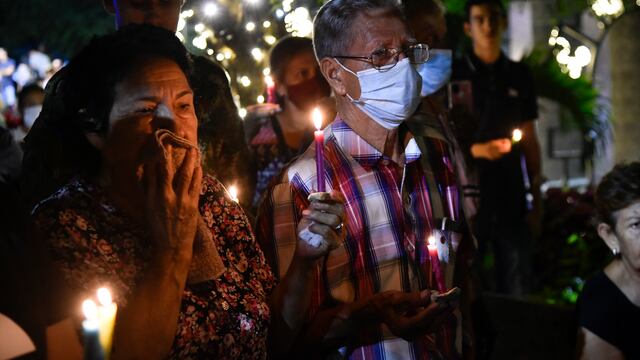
[{"x1": 313, "y1": 0, "x2": 404, "y2": 62}]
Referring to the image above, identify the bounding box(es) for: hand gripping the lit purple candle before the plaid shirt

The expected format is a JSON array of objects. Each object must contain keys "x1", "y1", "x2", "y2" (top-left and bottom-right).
[{"x1": 296, "y1": 190, "x2": 346, "y2": 261}]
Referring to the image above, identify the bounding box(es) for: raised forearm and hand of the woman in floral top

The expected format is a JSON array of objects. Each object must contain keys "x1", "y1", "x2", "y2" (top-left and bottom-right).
[{"x1": 111, "y1": 149, "x2": 202, "y2": 359}]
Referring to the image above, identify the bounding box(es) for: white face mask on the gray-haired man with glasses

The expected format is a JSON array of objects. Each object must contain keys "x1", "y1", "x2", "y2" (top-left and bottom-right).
[{"x1": 336, "y1": 58, "x2": 420, "y2": 129}]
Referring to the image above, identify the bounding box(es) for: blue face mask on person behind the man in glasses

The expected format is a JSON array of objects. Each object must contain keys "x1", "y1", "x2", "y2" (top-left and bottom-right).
[{"x1": 417, "y1": 49, "x2": 453, "y2": 97}]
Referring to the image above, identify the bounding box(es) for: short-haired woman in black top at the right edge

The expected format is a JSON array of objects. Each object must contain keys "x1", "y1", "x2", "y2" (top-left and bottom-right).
[{"x1": 577, "y1": 162, "x2": 640, "y2": 360}]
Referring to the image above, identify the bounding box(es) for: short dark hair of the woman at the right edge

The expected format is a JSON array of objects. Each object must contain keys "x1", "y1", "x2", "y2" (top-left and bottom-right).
[{"x1": 595, "y1": 161, "x2": 640, "y2": 227}]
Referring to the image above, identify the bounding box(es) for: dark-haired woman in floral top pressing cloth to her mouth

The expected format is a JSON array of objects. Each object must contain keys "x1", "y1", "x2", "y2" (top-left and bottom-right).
[{"x1": 25, "y1": 26, "x2": 343, "y2": 359}]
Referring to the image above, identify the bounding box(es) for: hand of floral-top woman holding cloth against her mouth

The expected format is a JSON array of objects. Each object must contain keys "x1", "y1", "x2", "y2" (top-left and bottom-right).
[{"x1": 145, "y1": 145, "x2": 202, "y2": 260}]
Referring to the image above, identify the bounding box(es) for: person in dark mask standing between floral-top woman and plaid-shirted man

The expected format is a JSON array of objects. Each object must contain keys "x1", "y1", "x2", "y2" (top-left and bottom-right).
[{"x1": 245, "y1": 36, "x2": 331, "y2": 209}]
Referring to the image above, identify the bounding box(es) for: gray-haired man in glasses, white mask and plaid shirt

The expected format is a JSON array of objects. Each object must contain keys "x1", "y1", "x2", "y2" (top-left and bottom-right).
[{"x1": 258, "y1": 0, "x2": 472, "y2": 359}]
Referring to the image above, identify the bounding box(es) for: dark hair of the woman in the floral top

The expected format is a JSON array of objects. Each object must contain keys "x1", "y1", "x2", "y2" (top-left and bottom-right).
[{"x1": 22, "y1": 25, "x2": 191, "y2": 207}]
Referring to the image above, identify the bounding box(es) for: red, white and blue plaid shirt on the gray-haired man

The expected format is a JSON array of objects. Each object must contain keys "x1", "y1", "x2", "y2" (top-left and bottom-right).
[{"x1": 257, "y1": 118, "x2": 458, "y2": 359}]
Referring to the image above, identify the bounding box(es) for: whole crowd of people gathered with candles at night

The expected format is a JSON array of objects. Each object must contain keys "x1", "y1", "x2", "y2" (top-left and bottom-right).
[{"x1": 0, "y1": 0, "x2": 640, "y2": 359}]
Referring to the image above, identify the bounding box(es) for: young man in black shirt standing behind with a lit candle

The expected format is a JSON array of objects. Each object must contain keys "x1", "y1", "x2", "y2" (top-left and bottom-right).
[{"x1": 452, "y1": 0, "x2": 542, "y2": 297}]
